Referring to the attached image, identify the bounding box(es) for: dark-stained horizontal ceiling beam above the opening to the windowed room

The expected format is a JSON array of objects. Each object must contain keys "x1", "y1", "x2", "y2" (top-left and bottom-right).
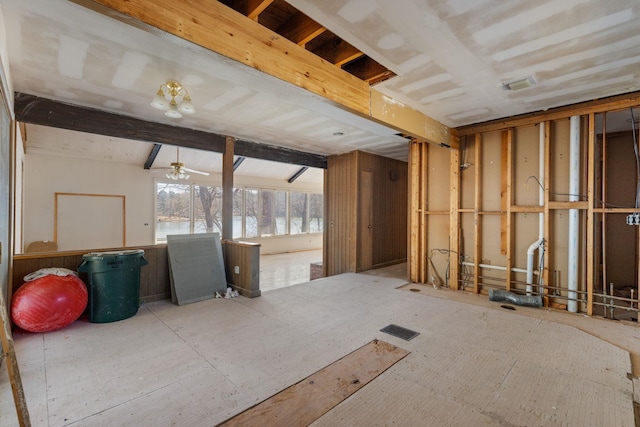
[{"x1": 15, "y1": 92, "x2": 327, "y2": 169}]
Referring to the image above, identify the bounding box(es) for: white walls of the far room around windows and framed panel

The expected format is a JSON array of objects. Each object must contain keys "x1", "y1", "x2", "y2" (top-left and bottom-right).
[{"x1": 24, "y1": 149, "x2": 322, "y2": 254}]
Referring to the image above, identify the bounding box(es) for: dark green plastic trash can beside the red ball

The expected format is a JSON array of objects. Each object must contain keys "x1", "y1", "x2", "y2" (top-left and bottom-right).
[{"x1": 78, "y1": 249, "x2": 149, "y2": 323}]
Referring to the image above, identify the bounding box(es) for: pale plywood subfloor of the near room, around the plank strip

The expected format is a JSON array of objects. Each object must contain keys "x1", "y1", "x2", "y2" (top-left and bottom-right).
[{"x1": 0, "y1": 267, "x2": 638, "y2": 427}]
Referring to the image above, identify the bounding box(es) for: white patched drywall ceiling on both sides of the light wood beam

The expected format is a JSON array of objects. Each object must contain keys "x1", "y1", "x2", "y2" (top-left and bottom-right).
[{"x1": 0, "y1": 0, "x2": 640, "y2": 174}]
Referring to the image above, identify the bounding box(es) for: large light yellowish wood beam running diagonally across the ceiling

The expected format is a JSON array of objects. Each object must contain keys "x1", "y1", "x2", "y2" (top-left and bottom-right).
[{"x1": 80, "y1": 0, "x2": 457, "y2": 148}]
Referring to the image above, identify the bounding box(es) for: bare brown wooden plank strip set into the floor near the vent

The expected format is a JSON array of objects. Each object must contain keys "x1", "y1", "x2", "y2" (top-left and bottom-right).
[{"x1": 219, "y1": 340, "x2": 409, "y2": 427}]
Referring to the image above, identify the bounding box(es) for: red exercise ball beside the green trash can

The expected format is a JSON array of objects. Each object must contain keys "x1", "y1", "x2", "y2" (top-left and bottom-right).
[{"x1": 11, "y1": 274, "x2": 88, "y2": 332}]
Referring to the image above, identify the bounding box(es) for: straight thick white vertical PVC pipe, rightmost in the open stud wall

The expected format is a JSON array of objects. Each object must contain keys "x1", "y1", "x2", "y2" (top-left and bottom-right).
[{"x1": 567, "y1": 116, "x2": 580, "y2": 313}]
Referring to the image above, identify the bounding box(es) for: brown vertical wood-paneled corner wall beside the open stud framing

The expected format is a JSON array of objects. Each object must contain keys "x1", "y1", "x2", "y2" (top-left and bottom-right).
[{"x1": 324, "y1": 151, "x2": 408, "y2": 276}]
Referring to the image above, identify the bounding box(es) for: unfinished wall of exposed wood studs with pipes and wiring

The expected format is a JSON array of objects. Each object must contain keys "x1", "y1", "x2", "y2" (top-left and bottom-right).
[{"x1": 409, "y1": 97, "x2": 640, "y2": 320}]
